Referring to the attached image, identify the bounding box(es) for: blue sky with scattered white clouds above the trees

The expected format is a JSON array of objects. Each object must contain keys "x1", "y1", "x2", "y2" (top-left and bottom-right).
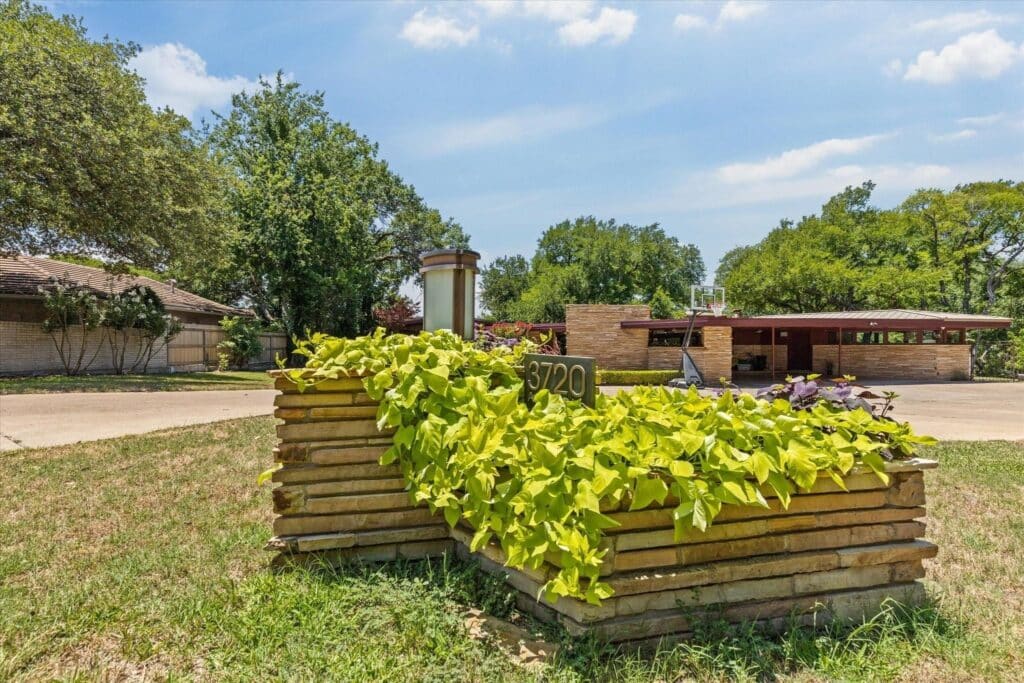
[{"x1": 49, "y1": 1, "x2": 1024, "y2": 275}]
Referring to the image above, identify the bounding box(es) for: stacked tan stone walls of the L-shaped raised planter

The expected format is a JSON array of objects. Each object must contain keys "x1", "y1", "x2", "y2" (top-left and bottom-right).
[{"x1": 268, "y1": 370, "x2": 937, "y2": 641}]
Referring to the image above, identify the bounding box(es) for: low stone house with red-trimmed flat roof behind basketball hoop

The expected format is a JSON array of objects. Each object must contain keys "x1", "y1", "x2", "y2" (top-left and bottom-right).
[{"x1": 534, "y1": 304, "x2": 1011, "y2": 385}]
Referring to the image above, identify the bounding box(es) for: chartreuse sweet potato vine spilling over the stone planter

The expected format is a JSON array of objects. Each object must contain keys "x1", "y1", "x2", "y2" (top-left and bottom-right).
[{"x1": 290, "y1": 330, "x2": 926, "y2": 603}]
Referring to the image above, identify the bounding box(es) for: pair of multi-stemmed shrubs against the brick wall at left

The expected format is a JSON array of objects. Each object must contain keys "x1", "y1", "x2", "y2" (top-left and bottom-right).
[{"x1": 39, "y1": 278, "x2": 183, "y2": 375}]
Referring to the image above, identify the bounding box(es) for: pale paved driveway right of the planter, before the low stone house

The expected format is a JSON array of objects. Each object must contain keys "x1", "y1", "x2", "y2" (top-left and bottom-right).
[{"x1": 602, "y1": 381, "x2": 1024, "y2": 441}]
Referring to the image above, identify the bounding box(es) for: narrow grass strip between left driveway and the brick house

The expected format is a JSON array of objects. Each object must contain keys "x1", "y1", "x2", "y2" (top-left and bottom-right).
[{"x1": 0, "y1": 370, "x2": 273, "y2": 395}]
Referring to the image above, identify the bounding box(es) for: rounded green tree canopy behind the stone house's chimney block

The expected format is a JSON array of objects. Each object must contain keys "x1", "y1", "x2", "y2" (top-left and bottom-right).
[{"x1": 480, "y1": 216, "x2": 705, "y2": 322}]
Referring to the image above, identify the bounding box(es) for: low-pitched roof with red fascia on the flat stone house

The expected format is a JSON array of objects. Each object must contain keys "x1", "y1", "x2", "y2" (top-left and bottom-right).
[{"x1": 622, "y1": 308, "x2": 1013, "y2": 330}]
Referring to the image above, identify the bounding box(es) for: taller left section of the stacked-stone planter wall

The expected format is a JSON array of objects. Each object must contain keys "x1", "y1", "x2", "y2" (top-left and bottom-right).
[{"x1": 268, "y1": 377, "x2": 454, "y2": 562}]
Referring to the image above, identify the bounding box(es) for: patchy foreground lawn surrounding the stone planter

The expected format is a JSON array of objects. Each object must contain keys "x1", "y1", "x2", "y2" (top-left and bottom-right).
[{"x1": 0, "y1": 418, "x2": 1024, "y2": 682}]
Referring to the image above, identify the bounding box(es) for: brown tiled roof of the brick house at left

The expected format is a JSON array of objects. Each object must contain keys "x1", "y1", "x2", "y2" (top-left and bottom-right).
[{"x1": 0, "y1": 256, "x2": 252, "y2": 315}]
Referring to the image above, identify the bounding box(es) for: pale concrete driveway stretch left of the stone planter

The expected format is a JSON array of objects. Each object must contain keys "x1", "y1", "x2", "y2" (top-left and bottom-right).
[{"x1": 0, "y1": 389, "x2": 276, "y2": 451}]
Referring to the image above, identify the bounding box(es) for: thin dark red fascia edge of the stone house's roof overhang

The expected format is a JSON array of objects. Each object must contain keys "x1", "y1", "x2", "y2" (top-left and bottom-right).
[{"x1": 620, "y1": 315, "x2": 1011, "y2": 330}]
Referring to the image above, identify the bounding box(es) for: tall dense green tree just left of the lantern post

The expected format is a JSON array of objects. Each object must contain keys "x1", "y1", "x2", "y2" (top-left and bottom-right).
[{"x1": 205, "y1": 74, "x2": 467, "y2": 337}]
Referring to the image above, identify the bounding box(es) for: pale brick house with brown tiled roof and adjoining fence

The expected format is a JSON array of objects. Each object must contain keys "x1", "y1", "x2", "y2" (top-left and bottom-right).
[{"x1": 0, "y1": 256, "x2": 287, "y2": 375}]
